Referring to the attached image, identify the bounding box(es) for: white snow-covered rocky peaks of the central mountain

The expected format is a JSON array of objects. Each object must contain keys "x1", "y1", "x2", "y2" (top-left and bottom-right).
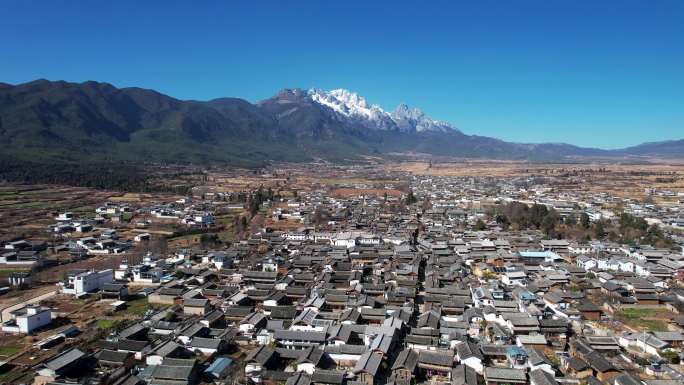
[{"x1": 307, "y1": 89, "x2": 457, "y2": 132}]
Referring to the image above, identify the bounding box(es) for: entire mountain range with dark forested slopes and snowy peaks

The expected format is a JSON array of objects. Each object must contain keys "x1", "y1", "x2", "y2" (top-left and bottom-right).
[{"x1": 0, "y1": 79, "x2": 684, "y2": 166}]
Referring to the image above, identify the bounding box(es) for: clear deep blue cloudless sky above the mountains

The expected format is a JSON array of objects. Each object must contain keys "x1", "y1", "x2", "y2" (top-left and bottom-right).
[{"x1": 0, "y1": 0, "x2": 684, "y2": 148}]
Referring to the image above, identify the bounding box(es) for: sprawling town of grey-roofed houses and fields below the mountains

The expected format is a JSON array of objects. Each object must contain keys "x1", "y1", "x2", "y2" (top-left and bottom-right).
[{"x1": 0, "y1": 160, "x2": 684, "y2": 385}]
